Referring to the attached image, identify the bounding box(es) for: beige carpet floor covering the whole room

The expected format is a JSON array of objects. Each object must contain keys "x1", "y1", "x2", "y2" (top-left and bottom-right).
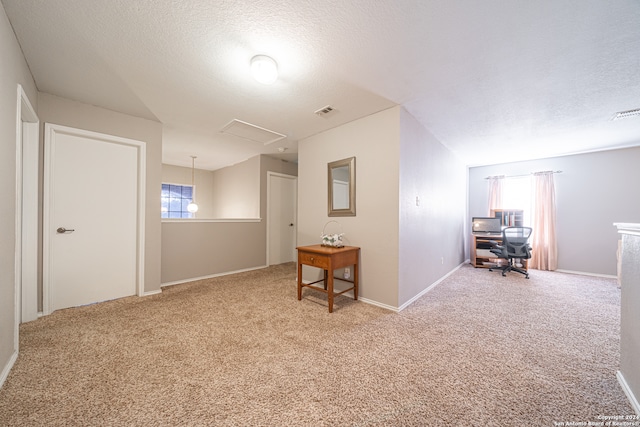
[{"x1": 0, "y1": 264, "x2": 633, "y2": 426}]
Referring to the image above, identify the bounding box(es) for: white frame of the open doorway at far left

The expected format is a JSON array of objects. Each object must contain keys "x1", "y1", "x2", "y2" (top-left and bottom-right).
[{"x1": 14, "y1": 84, "x2": 40, "y2": 336}]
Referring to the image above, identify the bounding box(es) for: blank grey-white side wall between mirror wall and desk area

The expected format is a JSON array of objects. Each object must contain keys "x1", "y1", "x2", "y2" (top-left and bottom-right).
[{"x1": 398, "y1": 109, "x2": 467, "y2": 306}]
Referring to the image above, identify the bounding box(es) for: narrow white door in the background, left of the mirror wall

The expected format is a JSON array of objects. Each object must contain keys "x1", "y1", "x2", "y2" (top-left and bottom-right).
[{"x1": 267, "y1": 173, "x2": 298, "y2": 265}]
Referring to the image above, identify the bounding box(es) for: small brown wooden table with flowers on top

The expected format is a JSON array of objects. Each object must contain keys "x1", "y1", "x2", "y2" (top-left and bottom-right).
[{"x1": 296, "y1": 245, "x2": 360, "y2": 313}]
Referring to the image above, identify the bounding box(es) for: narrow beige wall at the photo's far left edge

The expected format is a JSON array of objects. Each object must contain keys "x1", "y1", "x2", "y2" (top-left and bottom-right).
[{"x1": 0, "y1": 4, "x2": 38, "y2": 381}]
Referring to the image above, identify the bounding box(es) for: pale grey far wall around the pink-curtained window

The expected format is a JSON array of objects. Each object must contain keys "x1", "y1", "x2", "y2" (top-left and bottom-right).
[{"x1": 467, "y1": 147, "x2": 640, "y2": 275}]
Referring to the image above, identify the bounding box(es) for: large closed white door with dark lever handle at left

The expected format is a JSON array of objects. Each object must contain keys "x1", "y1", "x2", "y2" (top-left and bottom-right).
[{"x1": 43, "y1": 124, "x2": 143, "y2": 312}]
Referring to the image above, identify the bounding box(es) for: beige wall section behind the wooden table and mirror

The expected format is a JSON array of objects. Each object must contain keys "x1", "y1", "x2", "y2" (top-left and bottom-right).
[{"x1": 298, "y1": 107, "x2": 400, "y2": 308}]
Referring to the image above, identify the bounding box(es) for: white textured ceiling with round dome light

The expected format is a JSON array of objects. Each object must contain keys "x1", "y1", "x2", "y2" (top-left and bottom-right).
[{"x1": 1, "y1": 0, "x2": 640, "y2": 169}]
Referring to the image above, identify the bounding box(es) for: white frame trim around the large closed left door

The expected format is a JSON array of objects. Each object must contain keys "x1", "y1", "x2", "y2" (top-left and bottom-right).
[{"x1": 42, "y1": 123, "x2": 147, "y2": 314}]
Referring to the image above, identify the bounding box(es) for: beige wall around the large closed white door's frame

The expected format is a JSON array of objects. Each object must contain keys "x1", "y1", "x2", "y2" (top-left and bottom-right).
[{"x1": 38, "y1": 93, "x2": 162, "y2": 292}]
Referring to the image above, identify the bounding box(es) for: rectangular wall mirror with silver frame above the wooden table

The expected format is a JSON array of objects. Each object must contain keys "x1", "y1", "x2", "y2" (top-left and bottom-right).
[{"x1": 328, "y1": 157, "x2": 356, "y2": 216}]
